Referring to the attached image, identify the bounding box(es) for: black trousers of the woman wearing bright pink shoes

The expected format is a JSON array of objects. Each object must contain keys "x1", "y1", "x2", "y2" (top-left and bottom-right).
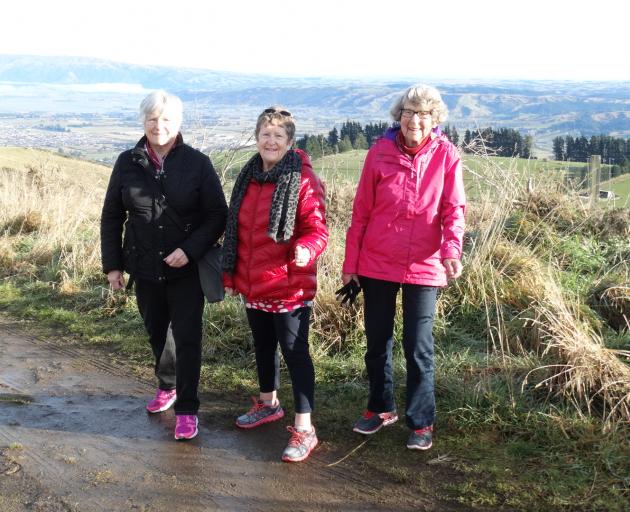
[{"x1": 136, "y1": 273, "x2": 204, "y2": 414}]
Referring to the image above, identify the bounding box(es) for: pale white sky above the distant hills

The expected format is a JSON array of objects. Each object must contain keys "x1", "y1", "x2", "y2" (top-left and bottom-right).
[{"x1": 0, "y1": 0, "x2": 630, "y2": 80}]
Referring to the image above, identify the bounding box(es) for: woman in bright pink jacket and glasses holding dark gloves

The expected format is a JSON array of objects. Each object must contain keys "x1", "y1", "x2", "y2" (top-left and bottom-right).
[{"x1": 342, "y1": 85, "x2": 466, "y2": 450}]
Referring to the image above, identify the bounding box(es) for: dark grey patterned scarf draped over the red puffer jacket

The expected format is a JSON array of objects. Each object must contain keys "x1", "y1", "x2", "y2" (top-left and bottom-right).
[{"x1": 223, "y1": 150, "x2": 302, "y2": 274}]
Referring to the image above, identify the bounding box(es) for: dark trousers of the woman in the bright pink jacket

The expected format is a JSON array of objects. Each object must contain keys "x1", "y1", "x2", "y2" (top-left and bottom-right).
[{"x1": 359, "y1": 276, "x2": 437, "y2": 429}]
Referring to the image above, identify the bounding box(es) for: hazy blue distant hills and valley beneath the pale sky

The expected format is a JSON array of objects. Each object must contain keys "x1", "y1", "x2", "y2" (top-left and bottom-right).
[{"x1": 0, "y1": 55, "x2": 630, "y2": 154}]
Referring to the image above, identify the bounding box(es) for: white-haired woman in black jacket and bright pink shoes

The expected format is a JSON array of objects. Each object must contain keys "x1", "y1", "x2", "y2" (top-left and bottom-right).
[{"x1": 101, "y1": 91, "x2": 227, "y2": 439}]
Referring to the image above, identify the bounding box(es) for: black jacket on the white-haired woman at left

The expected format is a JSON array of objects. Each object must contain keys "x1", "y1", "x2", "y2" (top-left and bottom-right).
[{"x1": 101, "y1": 137, "x2": 227, "y2": 281}]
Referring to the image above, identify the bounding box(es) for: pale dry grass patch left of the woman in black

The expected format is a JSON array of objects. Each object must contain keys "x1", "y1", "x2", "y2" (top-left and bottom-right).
[{"x1": 0, "y1": 164, "x2": 104, "y2": 282}]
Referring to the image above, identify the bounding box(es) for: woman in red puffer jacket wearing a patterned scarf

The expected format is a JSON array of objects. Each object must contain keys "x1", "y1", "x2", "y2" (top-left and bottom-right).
[{"x1": 223, "y1": 107, "x2": 328, "y2": 462}]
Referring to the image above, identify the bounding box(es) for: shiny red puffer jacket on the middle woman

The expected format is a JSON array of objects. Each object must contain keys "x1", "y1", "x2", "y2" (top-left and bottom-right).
[{"x1": 223, "y1": 149, "x2": 328, "y2": 301}]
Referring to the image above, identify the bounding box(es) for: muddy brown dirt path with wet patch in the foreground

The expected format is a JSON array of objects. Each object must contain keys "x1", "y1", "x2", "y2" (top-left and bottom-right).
[{"x1": 0, "y1": 317, "x2": 459, "y2": 512}]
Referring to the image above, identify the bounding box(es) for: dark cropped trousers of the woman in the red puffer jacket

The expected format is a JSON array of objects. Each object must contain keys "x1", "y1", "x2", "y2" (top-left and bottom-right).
[{"x1": 247, "y1": 307, "x2": 315, "y2": 414}]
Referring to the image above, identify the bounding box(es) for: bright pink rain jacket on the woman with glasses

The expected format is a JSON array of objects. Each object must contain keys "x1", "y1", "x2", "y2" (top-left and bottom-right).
[{"x1": 343, "y1": 128, "x2": 466, "y2": 286}]
